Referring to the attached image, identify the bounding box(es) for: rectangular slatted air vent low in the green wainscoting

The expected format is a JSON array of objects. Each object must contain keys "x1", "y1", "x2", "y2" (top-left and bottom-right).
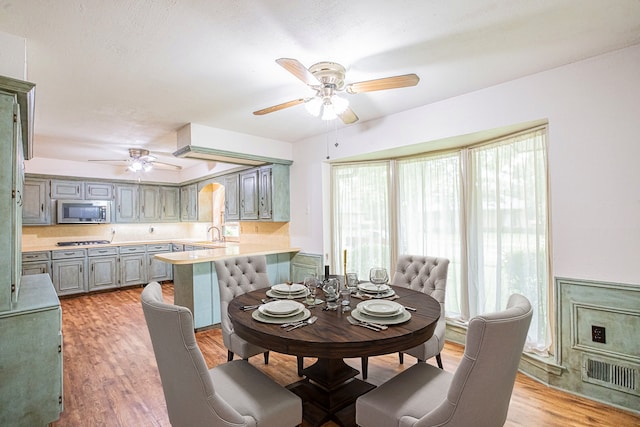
[{"x1": 582, "y1": 354, "x2": 640, "y2": 396}]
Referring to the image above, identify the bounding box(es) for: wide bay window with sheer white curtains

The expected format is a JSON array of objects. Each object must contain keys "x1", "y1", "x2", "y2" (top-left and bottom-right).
[{"x1": 332, "y1": 128, "x2": 551, "y2": 354}]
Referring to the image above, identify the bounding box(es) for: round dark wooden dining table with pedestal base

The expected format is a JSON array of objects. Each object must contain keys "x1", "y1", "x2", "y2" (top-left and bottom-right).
[{"x1": 228, "y1": 286, "x2": 440, "y2": 426}]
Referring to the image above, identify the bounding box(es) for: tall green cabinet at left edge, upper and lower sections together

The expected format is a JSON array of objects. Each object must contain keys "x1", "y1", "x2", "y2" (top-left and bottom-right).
[{"x1": 0, "y1": 77, "x2": 63, "y2": 427}]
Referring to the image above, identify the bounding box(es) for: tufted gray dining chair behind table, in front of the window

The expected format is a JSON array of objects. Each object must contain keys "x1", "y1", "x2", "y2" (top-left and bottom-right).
[{"x1": 391, "y1": 255, "x2": 449, "y2": 368}]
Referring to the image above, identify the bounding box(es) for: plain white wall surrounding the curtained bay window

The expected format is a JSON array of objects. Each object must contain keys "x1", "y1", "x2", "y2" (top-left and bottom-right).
[{"x1": 290, "y1": 45, "x2": 640, "y2": 284}]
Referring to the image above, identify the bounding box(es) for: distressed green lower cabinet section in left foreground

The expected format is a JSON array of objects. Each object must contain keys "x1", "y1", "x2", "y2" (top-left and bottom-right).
[{"x1": 0, "y1": 274, "x2": 63, "y2": 427}]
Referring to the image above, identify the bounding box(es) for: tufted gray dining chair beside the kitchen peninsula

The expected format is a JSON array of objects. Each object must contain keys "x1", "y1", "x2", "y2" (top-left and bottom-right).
[{"x1": 214, "y1": 255, "x2": 271, "y2": 364}]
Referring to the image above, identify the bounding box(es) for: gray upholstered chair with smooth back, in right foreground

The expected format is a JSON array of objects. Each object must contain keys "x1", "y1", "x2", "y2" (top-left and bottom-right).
[{"x1": 356, "y1": 294, "x2": 533, "y2": 427}]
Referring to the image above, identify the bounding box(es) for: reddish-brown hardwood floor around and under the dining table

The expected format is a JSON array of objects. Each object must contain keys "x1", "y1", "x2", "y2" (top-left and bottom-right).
[{"x1": 53, "y1": 284, "x2": 640, "y2": 427}]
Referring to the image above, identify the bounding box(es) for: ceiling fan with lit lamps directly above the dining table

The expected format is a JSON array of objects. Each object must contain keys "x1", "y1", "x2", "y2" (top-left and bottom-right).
[{"x1": 253, "y1": 58, "x2": 420, "y2": 124}]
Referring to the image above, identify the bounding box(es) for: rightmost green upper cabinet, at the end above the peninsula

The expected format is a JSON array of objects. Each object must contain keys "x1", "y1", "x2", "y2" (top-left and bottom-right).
[{"x1": 258, "y1": 164, "x2": 291, "y2": 222}]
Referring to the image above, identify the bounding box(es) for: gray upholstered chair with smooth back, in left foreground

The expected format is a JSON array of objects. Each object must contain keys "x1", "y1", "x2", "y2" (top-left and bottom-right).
[{"x1": 142, "y1": 282, "x2": 302, "y2": 427}]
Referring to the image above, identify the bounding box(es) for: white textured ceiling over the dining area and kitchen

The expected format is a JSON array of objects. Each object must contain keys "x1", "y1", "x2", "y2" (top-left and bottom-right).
[{"x1": 0, "y1": 0, "x2": 640, "y2": 167}]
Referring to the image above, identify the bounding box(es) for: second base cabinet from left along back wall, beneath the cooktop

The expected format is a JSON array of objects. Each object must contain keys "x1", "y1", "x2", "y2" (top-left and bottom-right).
[{"x1": 51, "y1": 249, "x2": 87, "y2": 295}]
